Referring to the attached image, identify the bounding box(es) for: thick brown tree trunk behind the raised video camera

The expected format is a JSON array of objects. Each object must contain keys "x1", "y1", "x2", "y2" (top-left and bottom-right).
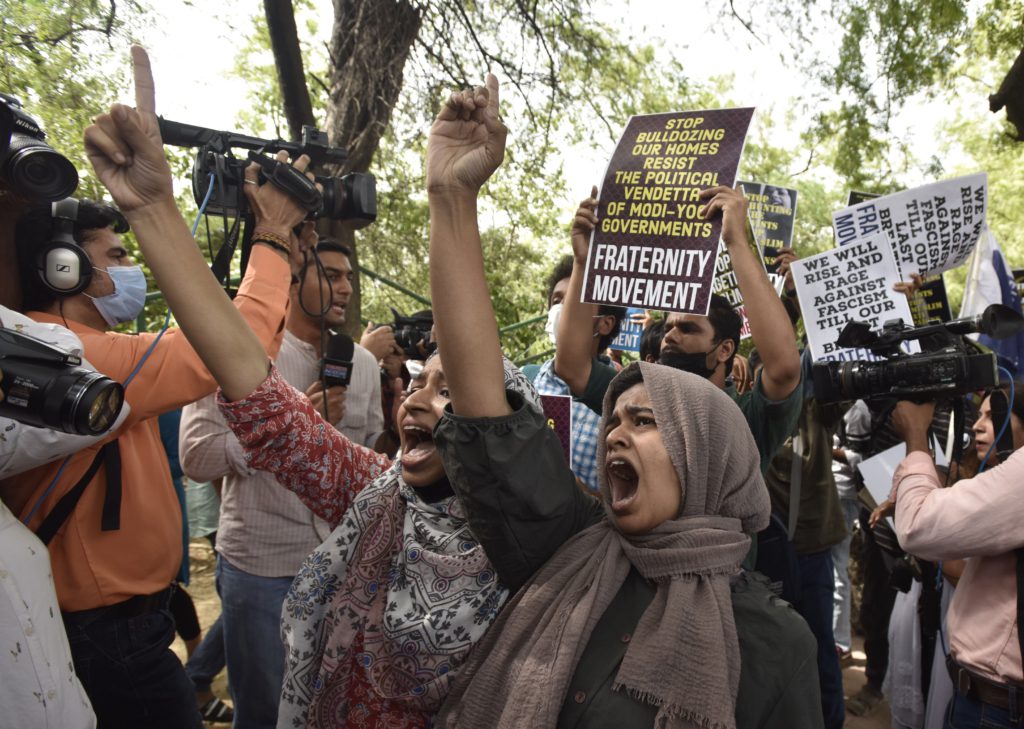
[{"x1": 327, "y1": 0, "x2": 422, "y2": 338}]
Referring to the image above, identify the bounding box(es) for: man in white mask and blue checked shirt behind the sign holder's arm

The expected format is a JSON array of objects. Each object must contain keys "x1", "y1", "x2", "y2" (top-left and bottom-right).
[{"x1": 523, "y1": 256, "x2": 626, "y2": 491}]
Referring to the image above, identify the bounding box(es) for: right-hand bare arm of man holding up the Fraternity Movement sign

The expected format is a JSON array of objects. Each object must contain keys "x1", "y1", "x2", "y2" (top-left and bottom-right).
[{"x1": 700, "y1": 186, "x2": 800, "y2": 400}]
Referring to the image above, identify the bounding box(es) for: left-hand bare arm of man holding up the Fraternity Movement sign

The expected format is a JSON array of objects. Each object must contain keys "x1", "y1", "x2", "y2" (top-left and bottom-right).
[{"x1": 555, "y1": 186, "x2": 597, "y2": 396}]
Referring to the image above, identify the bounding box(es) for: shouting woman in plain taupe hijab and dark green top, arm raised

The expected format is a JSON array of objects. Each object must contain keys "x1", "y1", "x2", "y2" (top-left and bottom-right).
[{"x1": 427, "y1": 77, "x2": 822, "y2": 729}]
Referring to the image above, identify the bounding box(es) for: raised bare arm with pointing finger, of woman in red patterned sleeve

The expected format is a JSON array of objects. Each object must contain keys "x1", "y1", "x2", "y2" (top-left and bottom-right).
[{"x1": 85, "y1": 46, "x2": 308, "y2": 399}]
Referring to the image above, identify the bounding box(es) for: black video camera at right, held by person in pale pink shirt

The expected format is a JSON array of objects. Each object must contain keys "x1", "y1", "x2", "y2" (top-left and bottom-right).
[{"x1": 812, "y1": 304, "x2": 1024, "y2": 402}]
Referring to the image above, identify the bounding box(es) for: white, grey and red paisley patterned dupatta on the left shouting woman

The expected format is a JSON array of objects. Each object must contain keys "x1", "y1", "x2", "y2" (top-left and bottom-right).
[{"x1": 278, "y1": 360, "x2": 540, "y2": 727}]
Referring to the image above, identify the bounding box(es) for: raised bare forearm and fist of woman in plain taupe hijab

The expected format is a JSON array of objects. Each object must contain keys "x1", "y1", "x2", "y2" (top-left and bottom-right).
[{"x1": 427, "y1": 74, "x2": 510, "y2": 418}]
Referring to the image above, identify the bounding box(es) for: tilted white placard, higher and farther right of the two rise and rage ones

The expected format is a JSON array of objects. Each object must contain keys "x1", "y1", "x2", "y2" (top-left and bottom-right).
[{"x1": 833, "y1": 172, "x2": 988, "y2": 280}]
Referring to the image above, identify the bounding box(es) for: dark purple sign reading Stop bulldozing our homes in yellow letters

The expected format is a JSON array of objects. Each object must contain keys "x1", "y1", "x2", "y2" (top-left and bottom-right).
[{"x1": 583, "y1": 109, "x2": 754, "y2": 314}]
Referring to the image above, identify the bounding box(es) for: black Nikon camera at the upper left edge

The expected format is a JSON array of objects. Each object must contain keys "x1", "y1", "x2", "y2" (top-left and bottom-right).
[{"x1": 0, "y1": 93, "x2": 78, "y2": 203}]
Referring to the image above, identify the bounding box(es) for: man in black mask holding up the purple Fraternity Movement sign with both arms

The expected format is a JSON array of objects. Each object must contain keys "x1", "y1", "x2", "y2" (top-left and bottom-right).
[{"x1": 555, "y1": 186, "x2": 803, "y2": 472}]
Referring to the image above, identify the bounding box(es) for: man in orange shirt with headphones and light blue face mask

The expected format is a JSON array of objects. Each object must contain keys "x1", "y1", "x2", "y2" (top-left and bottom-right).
[{"x1": 0, "y1": 53, "x2": 308, "y2": 729}]
